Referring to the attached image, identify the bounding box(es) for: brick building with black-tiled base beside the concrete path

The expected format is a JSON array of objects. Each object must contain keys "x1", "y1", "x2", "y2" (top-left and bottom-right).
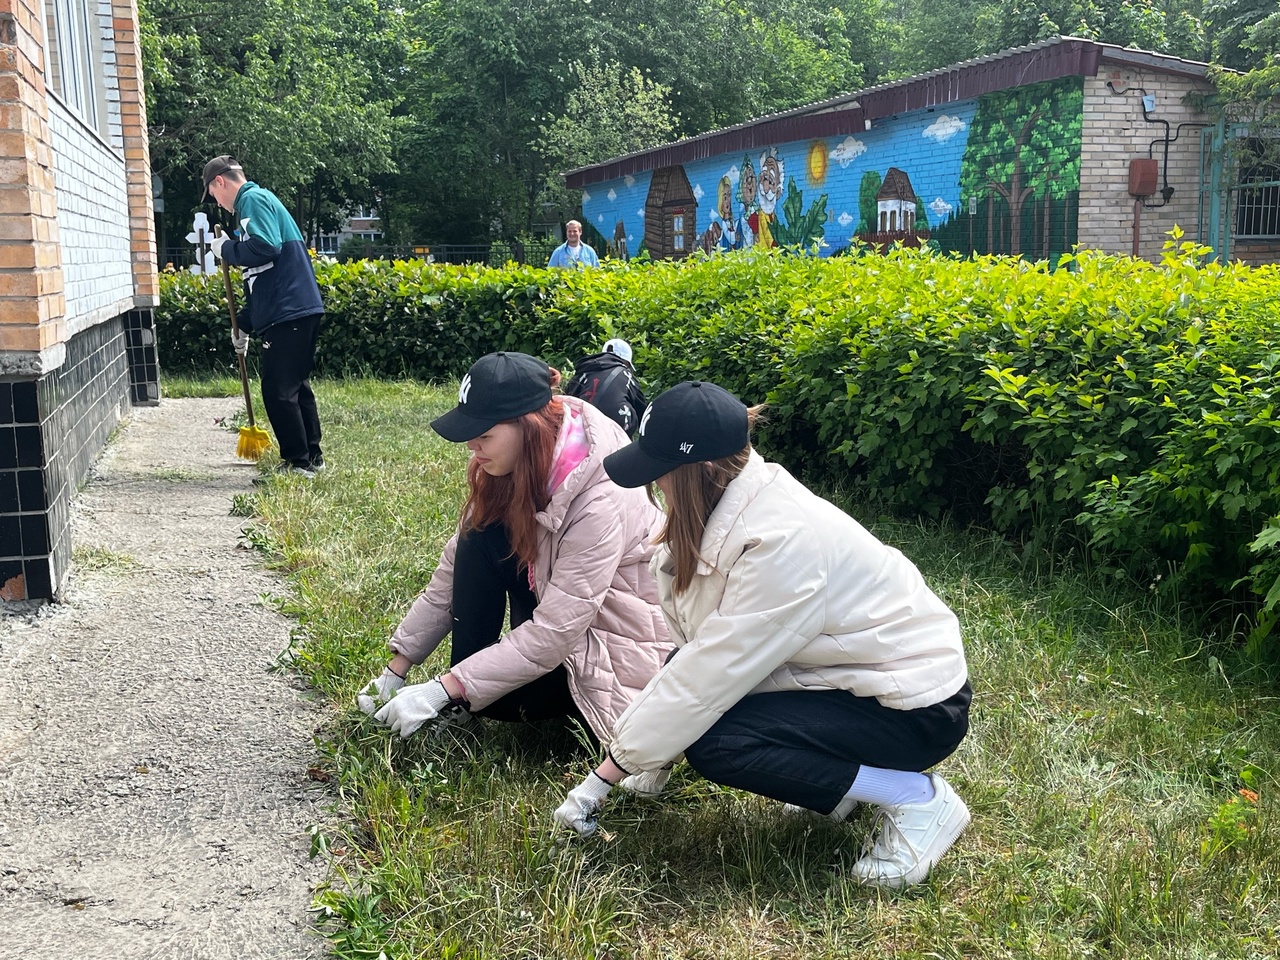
[{"x1": 0, "y1": 0, "x2": 160, "y2": 603}]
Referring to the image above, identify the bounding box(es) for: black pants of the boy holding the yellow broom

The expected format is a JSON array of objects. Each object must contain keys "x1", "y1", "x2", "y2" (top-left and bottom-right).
[{"x1": 261, "y1": 314, "x2": 324, "y2": 467}]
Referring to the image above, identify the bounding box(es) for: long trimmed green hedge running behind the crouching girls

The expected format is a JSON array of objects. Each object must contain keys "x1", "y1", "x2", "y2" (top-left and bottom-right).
[{"x1": 157, "y1": 233, "x2": 1280, "y2": 644}]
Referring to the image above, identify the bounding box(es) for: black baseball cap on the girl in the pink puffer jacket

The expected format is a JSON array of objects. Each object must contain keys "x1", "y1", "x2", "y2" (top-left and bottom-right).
[{"x1": 431, "y1": 352, "x2": 552, "y2": 443}]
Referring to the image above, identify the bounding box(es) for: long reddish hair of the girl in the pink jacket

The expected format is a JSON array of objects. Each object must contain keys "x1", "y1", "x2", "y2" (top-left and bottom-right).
[{"x1": 461, "y1": 367, "x2": 564, "y2": 568}]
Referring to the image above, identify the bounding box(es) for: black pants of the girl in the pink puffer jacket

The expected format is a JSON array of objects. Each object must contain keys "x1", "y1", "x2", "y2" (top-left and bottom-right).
[{"x1": 449, "y1": 524, "x2": 590, "y2": 731}]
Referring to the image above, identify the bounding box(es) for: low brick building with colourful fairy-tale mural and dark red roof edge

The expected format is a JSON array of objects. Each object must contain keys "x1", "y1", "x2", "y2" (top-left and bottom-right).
[{"x1": 566, "y1": 37, "x2": 1280, "y2": 262}]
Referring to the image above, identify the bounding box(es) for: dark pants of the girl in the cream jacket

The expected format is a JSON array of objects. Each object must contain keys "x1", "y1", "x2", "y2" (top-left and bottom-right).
[{"x1": 685, "y1": 682, "x2": 973, "y2": 813}]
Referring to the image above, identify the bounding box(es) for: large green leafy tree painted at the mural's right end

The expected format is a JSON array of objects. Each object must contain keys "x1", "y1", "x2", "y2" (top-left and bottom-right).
[{"x1": 960, "y1": 78, "x2": 1083, "y2": 253}]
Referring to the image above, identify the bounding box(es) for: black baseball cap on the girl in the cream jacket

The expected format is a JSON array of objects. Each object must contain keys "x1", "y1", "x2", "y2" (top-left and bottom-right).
[{"x1": 604, "y1": 380, "x2": 750, "y2": 486}]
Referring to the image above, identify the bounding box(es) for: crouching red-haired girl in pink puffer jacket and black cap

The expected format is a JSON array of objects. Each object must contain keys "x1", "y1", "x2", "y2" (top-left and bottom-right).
[{"x1": 358, "y1": 353, "x2": 669, "y2": 744}]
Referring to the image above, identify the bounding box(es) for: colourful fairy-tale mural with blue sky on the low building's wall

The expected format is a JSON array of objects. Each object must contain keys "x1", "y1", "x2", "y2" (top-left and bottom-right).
[{"x1": 582, "y1": 77, "x2": 1083, "y2": 260}]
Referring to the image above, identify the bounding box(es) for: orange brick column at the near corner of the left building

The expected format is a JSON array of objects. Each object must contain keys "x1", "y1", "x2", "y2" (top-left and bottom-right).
[{"x1": 0, "y1": 0, "x2": 67, "y2": 375}]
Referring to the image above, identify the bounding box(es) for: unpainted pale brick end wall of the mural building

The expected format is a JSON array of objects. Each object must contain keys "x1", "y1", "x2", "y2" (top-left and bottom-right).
[{"x1": 1079, "y1": 64, "x2": 1212, "y2": 260}]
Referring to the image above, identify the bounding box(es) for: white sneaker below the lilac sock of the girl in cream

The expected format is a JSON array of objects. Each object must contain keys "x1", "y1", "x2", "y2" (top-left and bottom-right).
[{"x1": 854, "y1": 773, "x2": 969, "y2": 890}]
